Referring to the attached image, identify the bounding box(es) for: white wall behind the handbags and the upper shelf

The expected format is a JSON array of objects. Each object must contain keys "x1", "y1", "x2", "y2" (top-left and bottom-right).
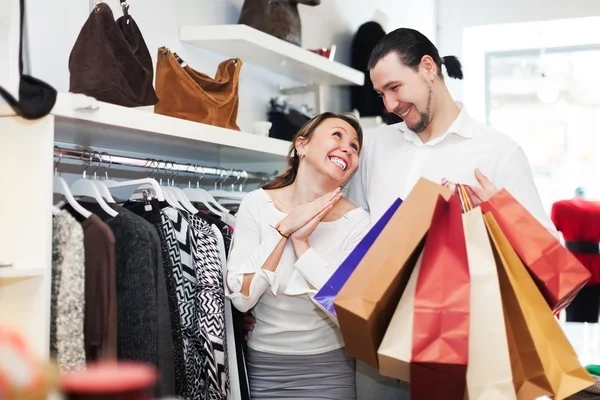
[{"x1": 22, "y1": 0, "x2": 436, "y2": 130}]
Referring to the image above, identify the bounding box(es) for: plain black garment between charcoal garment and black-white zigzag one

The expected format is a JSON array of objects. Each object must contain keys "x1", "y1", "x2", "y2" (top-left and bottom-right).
[{"x1": 123, "y1": 199, "x2": 187, "y2": 398}]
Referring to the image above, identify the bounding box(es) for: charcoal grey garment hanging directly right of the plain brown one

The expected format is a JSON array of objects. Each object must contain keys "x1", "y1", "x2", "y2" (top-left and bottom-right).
[{"x1": 66, "y1": 202, "x2": 164, "y2": 396}]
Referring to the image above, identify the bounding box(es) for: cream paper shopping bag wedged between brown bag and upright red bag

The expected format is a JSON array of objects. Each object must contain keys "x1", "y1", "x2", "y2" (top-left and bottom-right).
[{"x1": 377, "y1": 252, "x2": 423, "y2": 382}]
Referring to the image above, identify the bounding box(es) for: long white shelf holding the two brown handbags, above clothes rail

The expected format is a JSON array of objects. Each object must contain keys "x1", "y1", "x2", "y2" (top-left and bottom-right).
[{"x1": 51, "y1": 93, "x2": 290, "y2": 164}]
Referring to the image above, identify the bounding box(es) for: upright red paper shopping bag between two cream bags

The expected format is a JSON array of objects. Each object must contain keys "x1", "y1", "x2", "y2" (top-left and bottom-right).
[{"x1": 410, "y1": 193, "x2": 471, "y2": 400}]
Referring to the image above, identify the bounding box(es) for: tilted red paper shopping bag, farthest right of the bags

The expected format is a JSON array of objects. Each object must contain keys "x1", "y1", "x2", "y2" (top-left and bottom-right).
[{"x1": 481, "y1": 189, "x2": 591, "y2": 313}]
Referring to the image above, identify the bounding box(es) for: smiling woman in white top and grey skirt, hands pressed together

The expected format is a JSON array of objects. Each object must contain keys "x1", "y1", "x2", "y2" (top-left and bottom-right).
[{"x1": 226, "y1": 113, "x2": 369, "y2": 400}]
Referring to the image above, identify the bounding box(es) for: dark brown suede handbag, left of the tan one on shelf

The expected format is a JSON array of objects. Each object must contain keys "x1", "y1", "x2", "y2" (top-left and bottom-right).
[{"x1": 69, "y1": 0, "x2": 158, "y2": 107}]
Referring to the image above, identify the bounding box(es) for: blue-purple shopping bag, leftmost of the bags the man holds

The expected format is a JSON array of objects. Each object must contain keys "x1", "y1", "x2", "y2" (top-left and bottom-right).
[{"x1": 313, "y1": 199, "x2": 402, "y2": 324}]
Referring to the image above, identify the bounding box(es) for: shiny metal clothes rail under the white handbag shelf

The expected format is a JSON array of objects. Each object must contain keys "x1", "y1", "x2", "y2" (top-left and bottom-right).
[{"x1": 54, "y1": 146, "x2": 271, "y2": 184}]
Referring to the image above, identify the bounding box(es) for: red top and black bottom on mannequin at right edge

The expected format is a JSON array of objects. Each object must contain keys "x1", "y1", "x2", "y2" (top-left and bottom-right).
[{"x1": 551, "y1": 198, "x2": 600, "y2": 323}]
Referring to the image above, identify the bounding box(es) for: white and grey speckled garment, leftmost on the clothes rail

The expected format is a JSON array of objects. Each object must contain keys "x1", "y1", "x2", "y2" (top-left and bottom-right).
[{"x1": 50, "y1": 211, "x2": 86, "y2": 372}]
